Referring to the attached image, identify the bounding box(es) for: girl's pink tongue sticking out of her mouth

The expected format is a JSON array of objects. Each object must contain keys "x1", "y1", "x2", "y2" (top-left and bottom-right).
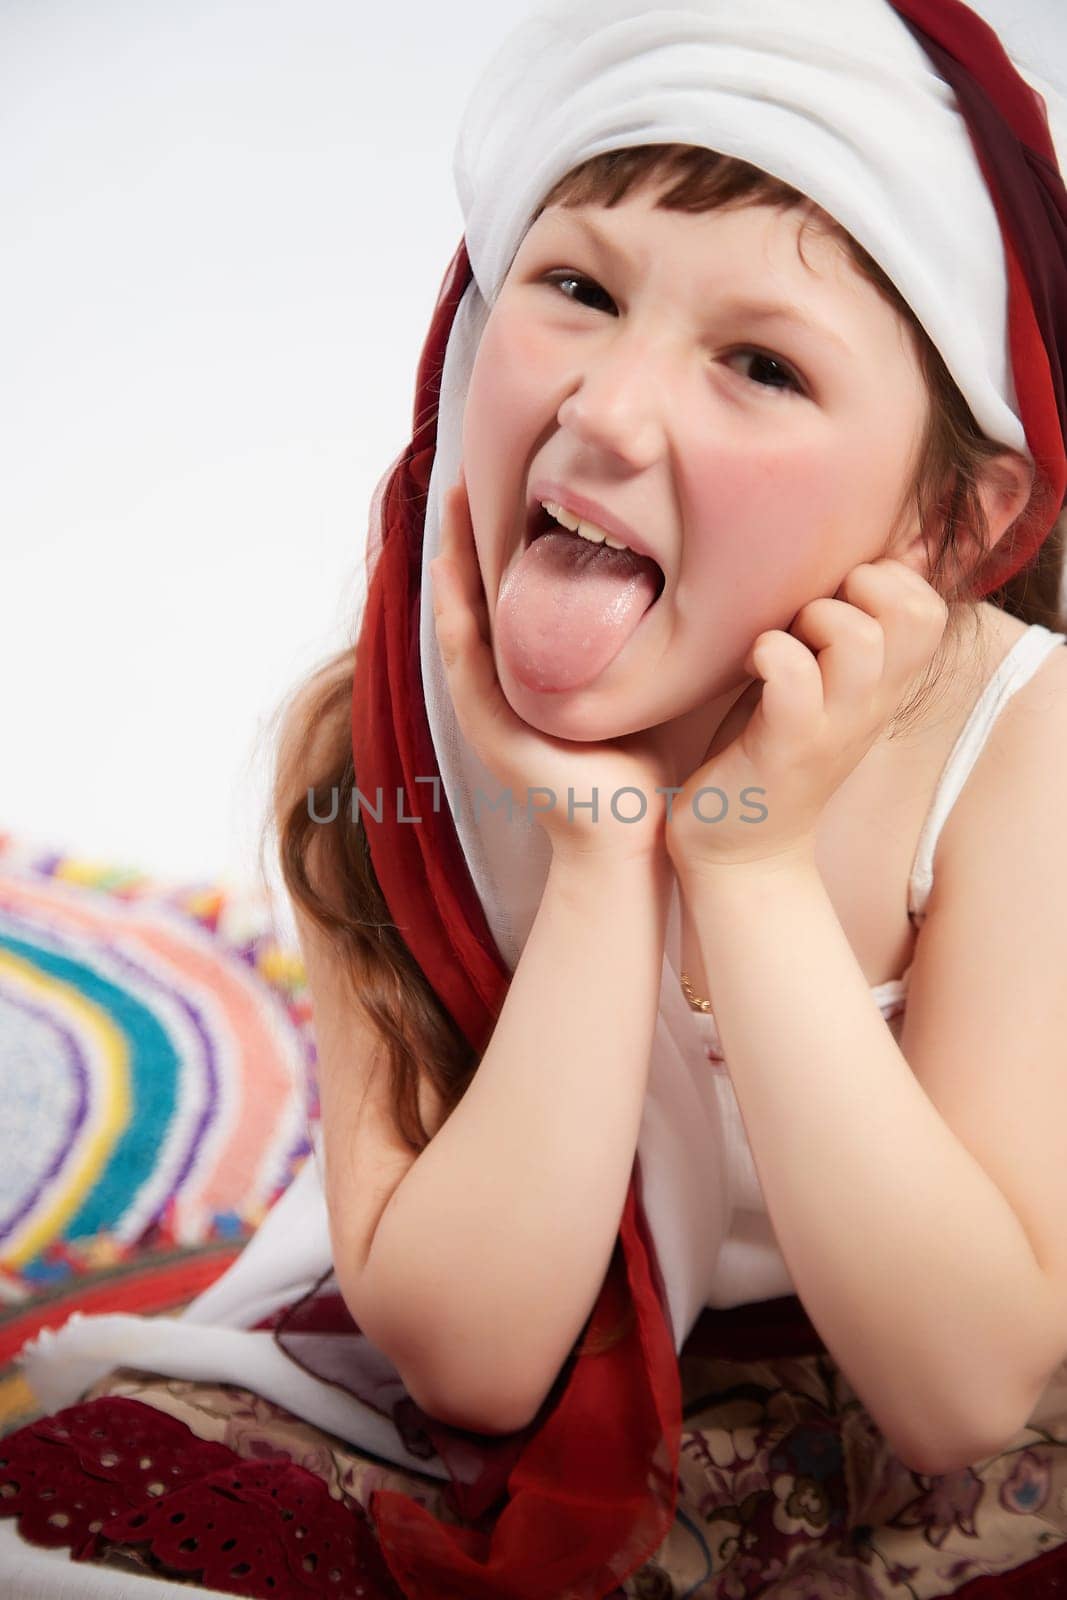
[{"x1": 496, "y1": 530, "x2": 661, "y2": 693}]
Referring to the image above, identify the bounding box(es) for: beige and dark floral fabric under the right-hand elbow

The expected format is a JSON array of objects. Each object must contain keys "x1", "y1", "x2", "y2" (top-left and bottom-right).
[{"x1": 624, "y1": 1354, "x2": 1067, "y2": 1600}]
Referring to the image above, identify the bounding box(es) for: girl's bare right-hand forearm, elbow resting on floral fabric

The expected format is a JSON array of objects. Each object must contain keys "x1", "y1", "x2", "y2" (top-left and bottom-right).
[{"x1": 683, "y1": 859, "x2": 1041, "y2": 1472}]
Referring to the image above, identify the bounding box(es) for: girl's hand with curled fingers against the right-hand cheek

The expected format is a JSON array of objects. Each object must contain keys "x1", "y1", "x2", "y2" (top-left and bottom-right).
[{"x1": 665, "y1": 557, "x2": 949, "y2": 870}]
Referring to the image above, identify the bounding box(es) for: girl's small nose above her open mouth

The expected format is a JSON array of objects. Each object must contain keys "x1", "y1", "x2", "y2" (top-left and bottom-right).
[{"x1": 557, "y1": 336, "x2": 667, "y2": 467}]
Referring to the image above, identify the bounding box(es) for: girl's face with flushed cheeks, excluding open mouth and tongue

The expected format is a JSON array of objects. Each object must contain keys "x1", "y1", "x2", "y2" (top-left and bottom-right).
[{"x1": 462, "y1": 190, "x2": 928, "y2": 765}]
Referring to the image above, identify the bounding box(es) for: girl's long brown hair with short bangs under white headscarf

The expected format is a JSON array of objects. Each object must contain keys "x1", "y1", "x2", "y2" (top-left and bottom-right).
[{"x1": 261, "y1": 146, "x2": 1067, "y2": 1152}]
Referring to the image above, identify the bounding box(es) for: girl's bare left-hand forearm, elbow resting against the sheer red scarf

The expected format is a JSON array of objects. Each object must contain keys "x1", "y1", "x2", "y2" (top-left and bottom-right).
[{"x1": 363, "y1": 858, "x2": 672, "y2": 1427}]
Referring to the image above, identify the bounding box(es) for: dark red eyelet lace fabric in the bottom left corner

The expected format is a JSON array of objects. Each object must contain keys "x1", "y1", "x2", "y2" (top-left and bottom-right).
[{"x1": 0, "y1": 1395, "x2": 403, "y2": 1600}]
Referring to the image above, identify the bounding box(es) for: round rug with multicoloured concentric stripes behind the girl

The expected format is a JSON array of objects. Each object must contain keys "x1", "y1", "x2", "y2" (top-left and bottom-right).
[{"x1": 0, "y1": 834, "x2": 318, "y2": 1434}]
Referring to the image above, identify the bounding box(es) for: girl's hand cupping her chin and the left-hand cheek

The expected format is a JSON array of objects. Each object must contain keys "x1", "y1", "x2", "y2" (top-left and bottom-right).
[{"x1": 430, "y1": 469, "x2": 677, "y2": 859}]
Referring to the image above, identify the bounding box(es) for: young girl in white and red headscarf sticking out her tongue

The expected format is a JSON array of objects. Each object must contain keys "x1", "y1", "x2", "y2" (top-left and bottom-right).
[{"x1": 0, "y1": 0, "x2": 1067, "y2": 1600}]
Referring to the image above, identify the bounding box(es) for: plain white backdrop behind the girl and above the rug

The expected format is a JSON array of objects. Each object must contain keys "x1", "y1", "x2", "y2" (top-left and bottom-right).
[{"x1": 0, "y1": 0, "x2": 1067, "y2": 915}]
